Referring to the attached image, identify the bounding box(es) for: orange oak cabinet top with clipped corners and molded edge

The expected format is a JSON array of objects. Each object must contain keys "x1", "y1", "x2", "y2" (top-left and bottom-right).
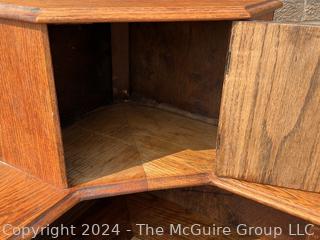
[{"x1": 0, "y1": 0, "x2": 281, "y2": 23}]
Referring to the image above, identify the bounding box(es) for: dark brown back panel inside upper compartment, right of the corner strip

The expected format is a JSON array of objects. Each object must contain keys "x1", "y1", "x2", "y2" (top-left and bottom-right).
[{"x1": 130, "y1": 22, "x2": 231, "y2": 119}]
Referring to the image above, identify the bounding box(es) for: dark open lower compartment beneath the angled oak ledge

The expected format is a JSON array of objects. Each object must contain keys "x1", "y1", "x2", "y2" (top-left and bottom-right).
[{"x1": 36, "y1": 187, "x2": 312, "y2": 240}]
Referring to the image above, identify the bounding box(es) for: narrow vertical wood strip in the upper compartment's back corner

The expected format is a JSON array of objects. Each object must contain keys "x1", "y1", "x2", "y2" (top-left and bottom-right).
[{"x1": 111, "y1": 23, "x2": 130, "y2": 100}]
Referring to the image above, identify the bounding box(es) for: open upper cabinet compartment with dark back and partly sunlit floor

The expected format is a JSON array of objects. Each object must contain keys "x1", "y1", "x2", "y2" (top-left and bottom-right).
[{"x1": 48, "y1": 21, "x2": 231, "y2": 191}]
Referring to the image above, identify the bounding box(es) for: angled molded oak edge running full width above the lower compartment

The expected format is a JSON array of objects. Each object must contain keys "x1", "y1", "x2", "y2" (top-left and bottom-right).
[{"x1": 0, "y1": 166, "x2": 320, "y2": 239}]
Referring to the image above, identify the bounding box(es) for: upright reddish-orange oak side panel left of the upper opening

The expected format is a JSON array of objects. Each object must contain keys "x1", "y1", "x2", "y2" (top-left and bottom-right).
[{"x1": 0, "y1": 20, "x2": 66, "y2": 187}]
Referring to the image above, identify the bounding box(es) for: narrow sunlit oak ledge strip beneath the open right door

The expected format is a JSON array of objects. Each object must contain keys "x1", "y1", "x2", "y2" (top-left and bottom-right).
[{"x1": 211, "y1": 174, "x2": 320, "y2": 225}]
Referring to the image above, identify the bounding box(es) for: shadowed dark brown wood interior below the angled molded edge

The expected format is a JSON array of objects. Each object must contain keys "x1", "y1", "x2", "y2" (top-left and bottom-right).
[{"x1": 37, "y1": 187, "x2": 319, "y2": 240}]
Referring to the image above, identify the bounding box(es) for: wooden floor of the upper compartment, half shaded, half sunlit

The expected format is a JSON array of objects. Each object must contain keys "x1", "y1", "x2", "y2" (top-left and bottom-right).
[{"x1": 63, "y1": 103, "x2": 217, "y2": 195}]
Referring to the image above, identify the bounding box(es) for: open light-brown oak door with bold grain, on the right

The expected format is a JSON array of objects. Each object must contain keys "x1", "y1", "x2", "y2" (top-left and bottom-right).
[{"x1": 216, "y1": 22, "x2": 320, "y2": 192}]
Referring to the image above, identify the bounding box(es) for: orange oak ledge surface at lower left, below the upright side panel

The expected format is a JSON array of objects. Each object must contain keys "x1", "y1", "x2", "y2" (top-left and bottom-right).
[{"x1": 0, "y1": 163, "x2": 78, "y2": 239}]
